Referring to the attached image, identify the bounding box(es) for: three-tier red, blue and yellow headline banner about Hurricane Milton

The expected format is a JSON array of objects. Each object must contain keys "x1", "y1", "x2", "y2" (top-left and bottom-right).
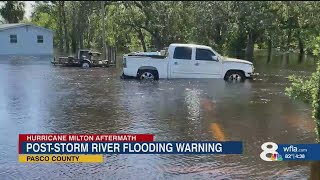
[{"x1": 18, "y1": 134, "x2": 243, "y2": 163}]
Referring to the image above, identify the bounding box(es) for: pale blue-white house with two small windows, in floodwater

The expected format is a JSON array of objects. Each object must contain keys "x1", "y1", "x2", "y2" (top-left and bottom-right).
[{"x1": 0, "y1": 23, "x2": 53, "y2": 55}]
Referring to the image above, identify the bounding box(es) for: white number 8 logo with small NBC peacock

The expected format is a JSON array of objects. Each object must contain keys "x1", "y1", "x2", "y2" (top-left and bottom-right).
[{"x1": 260, "y1": 142, "x2": 283, "y2": 161}]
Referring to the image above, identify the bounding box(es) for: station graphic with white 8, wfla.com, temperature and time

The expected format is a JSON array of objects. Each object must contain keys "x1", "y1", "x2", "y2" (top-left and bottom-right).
[{"x1": 260, "y1": 142, "x2": 320, "y2": 161}]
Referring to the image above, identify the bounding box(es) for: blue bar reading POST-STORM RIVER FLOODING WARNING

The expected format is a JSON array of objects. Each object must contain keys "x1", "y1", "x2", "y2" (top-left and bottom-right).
[{"x1": 21, "y1": 141, "x2": 243, "y2": 154}]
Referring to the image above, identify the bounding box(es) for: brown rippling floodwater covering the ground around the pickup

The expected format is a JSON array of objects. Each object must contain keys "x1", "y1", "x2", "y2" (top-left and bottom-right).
[{"x1": 0, "y1": 52, "x2": 316, "y2": 179}]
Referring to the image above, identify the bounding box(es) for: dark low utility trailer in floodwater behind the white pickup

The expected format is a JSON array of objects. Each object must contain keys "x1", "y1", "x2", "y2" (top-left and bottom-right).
[{"x1": 51, "y1": 49, "x2": 109, "y2": 68}]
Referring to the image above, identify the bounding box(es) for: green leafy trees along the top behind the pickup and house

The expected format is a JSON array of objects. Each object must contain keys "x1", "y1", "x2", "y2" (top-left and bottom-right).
[{"x1": 0, "y1": 1, "x2": 320, "y2": 58}]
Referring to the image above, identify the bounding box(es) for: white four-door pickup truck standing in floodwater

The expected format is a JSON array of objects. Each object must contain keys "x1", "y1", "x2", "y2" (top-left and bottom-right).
[{"x1": 122, "y1": 44, "x2": 254, "y2": 82}]
